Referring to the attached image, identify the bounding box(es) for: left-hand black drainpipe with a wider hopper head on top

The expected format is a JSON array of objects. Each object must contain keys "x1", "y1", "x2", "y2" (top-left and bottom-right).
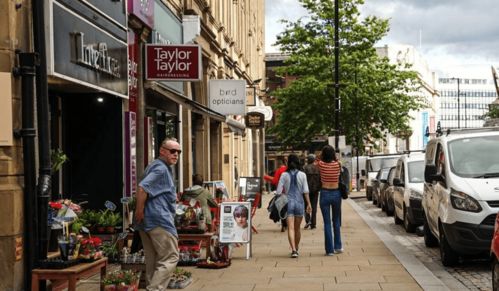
[{"x1": 14, "y1": 52, "x2": 38, "y2": 290}]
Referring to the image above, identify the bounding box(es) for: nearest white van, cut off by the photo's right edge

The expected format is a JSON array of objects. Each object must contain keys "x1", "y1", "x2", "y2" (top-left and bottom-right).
[{"x1": 422, "y1": 128, "x2": 499, "y2": 266}]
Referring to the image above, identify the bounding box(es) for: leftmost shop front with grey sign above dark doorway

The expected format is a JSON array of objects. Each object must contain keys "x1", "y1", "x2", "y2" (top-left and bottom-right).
[{"x1": 46, "y1": 0, "x2": 128, "y2": 209}]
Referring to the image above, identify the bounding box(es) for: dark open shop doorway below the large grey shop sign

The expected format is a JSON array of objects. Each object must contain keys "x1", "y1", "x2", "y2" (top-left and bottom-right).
[{"x1": 51, "y1": 94, "x2": 123, "y2": 209}]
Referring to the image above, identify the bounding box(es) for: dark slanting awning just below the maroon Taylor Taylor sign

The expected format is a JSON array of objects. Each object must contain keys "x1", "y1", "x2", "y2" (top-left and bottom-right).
[{"x1": 144, "y1": 81, "x2": 226, "y2": 122}]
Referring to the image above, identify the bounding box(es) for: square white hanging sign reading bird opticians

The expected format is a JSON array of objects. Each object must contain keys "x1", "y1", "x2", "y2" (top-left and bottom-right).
[{"x1": 209, "y1": 80, "x2": 246, "y2": 115}]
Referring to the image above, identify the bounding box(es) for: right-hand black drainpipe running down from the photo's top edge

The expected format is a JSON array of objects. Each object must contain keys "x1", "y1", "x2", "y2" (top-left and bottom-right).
[{"x1": 32, "y1": 1, "x2": 52, "y2": 260}]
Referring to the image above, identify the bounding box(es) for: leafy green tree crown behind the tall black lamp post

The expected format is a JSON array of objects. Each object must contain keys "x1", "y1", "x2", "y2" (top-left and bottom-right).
[{"x1": 270, "y1": 0, "x2": 422, "y2": 149}]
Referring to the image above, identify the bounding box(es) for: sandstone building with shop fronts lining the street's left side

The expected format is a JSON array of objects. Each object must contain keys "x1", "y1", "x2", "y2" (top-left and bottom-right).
[{"x1": 0, "y1": 0, "x2": 265, "y2": 290}]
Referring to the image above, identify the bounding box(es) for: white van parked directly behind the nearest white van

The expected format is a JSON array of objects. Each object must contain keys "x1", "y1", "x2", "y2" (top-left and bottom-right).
[{"x1": 393, "y1": 152, "x2": 424, "y2": 232}]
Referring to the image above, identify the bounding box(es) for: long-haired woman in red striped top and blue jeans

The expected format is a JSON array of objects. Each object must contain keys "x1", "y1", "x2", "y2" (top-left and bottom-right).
[{"x1": 315, "y1": 145, "x2": 343, "y2": 256}]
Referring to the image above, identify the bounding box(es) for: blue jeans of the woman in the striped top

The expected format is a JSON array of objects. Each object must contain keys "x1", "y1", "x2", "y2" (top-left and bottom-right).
[{"x1": 319, "y1": 189, "x2": 342, "y2": 254}]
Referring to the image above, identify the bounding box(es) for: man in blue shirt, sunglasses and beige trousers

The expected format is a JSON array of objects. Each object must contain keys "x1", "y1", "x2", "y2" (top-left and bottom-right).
[{"x1": 135, "y1": 139, "x2": 182, "y2": 291}]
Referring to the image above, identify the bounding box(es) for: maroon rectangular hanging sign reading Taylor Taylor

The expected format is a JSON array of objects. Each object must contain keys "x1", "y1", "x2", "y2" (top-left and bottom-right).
[{"x1": 146, "y1": 44, "x2": 201, "y2": 81}]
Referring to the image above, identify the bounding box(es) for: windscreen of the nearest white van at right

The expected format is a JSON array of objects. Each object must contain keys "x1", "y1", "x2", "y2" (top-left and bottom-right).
[{"x1": 449, "y1": 135, "x2": 499, "y2": 178}]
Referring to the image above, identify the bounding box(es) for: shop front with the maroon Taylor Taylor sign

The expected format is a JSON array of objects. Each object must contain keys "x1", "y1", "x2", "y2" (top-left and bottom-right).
[{"x1": 139, "y1": 1, "x2": 225, "y2": 192}]
